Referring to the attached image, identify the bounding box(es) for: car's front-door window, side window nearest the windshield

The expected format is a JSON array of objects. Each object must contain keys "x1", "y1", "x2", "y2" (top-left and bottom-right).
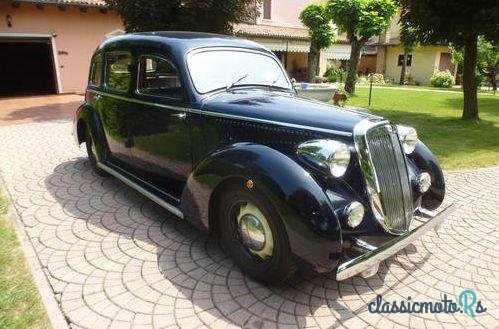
[{"x1": 137, "y1": 56, "x2": 182, "y2": 99}]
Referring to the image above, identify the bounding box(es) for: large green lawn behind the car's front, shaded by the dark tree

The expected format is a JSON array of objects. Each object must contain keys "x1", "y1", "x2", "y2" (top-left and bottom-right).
[{"x1": 347, "y1": 88, "x2": 499, "y2": 170}]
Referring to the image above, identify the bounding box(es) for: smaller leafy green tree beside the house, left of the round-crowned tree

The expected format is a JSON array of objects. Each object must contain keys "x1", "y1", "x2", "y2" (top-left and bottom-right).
[{"x1": 300, "y1": 3, "x2": 335, "y2": 82}]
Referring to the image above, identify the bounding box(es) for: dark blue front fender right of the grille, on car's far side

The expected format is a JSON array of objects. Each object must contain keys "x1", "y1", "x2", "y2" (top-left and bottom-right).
[{"x1": 409, "y1": 141, "x2": 445, "y2": 210}]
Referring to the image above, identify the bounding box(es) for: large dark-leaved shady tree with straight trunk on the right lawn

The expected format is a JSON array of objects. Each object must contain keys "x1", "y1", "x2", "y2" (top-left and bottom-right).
[{"x1": 398, "y1": 0, "x2": 499, "y2": 121}]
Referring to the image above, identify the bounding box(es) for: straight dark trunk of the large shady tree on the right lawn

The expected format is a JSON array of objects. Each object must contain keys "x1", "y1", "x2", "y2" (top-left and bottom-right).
[{"x1": 462, "y1": 34, "x2": 479, "y2": 121}]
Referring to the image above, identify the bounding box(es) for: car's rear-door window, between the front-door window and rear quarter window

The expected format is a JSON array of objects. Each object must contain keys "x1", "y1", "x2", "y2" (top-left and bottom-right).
[{"x1": 106, "y1": 53, "x2": 132, "y2": 92}]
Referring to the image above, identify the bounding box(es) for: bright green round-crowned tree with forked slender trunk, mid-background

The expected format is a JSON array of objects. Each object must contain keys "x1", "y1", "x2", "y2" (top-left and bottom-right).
[{"x1": 327, "y1": 0, "x2": 397, "y2": 93}]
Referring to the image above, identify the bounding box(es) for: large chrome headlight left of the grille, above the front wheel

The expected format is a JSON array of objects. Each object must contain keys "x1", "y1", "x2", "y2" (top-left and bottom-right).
[{"x1": 297, "y1": 139, "x2": 350, "y2": 177}]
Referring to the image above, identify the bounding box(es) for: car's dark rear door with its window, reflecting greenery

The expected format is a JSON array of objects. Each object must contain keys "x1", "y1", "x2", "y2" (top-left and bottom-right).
[{"x1": 98, "y1": 51, "x2": 133, "y2": 166}]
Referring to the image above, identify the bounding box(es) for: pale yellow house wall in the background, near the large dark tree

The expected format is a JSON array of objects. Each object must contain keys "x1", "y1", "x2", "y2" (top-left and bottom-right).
[{"x1": 384, "y1": 46, "x2": 449, "y2": 85}]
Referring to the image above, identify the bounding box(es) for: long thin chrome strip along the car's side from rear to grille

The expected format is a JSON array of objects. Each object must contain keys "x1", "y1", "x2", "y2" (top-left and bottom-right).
[{"x1": 91, "y1": 89, "x2": 352, "y2": 137}]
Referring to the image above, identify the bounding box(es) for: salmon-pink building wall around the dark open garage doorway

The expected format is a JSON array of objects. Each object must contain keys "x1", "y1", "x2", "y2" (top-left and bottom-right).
[{"x1": 0, "y1": 2, "x2": 123, "y2": 93}]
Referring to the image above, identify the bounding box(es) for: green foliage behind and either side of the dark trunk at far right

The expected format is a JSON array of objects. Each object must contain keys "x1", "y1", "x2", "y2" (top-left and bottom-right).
[{"x1": 451, "y1": 36, "x2": 499, "y2": 93}]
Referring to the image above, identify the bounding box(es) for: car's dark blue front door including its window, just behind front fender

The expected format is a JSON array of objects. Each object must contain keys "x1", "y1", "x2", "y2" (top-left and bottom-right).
[{"x1": 130, "y1": 54, "x2": 192, "y2": 198}]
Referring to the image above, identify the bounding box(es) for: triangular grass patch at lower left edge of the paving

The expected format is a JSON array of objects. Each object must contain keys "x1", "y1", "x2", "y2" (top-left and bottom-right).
[{"x1": 0, "y1": 188, "x2": 50, "y2": 328}]
